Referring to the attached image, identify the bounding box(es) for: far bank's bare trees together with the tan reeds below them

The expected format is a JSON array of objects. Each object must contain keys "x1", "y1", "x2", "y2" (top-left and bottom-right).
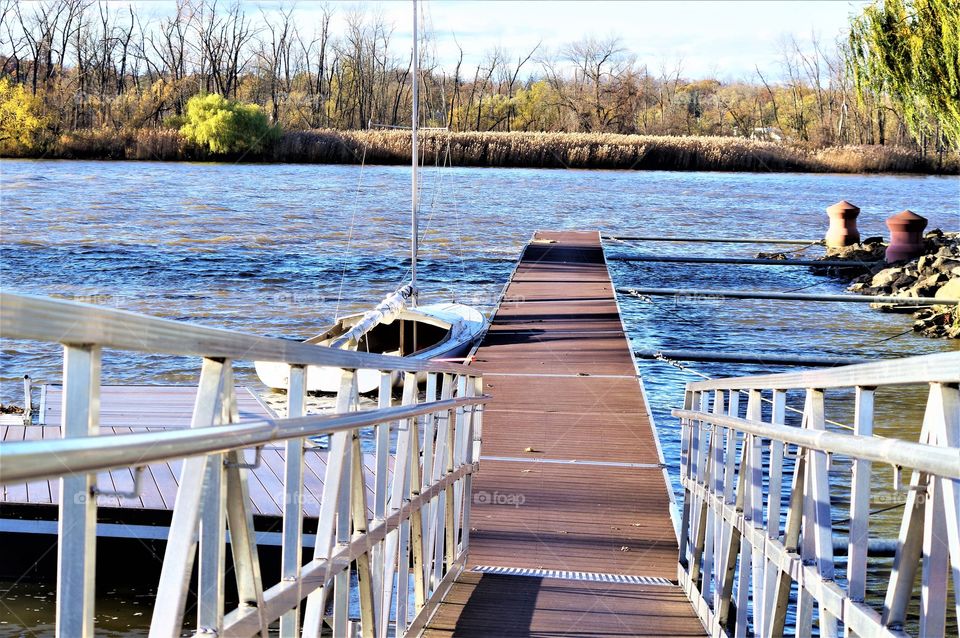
[{"x1": 0, "y1": 0, "x2": 957, "y2": 172}]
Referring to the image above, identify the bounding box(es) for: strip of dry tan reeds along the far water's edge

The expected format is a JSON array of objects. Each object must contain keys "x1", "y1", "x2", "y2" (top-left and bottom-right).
[{"x1": 11, "y1": 129, "x2": 960, "y2": 175}]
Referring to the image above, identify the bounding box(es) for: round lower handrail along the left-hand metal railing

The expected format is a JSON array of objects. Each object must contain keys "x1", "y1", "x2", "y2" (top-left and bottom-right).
[{"x1": 0, "y1": 395, "x2": 490, "y2": 484}]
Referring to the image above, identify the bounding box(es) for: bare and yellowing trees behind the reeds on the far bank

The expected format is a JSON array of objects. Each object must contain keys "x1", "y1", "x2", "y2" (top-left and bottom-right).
[{"x1": 0, "y1": 0, "x2": 956, "y2": 158}]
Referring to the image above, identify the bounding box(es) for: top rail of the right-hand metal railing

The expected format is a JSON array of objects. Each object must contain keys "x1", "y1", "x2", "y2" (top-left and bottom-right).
[{"x1": 687, "y1": 352, "x2": 960, "y2": 392}]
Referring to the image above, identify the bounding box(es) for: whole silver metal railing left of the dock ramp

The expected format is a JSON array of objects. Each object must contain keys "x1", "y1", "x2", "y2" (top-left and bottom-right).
[{"x1": 0, "y1": 293, "x2": 487, "y2": 638}]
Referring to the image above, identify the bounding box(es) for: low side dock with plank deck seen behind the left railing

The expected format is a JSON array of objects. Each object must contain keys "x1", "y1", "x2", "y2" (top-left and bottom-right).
[{"x1": 0, "y1": 385, "x2": 373, "y2": 528}]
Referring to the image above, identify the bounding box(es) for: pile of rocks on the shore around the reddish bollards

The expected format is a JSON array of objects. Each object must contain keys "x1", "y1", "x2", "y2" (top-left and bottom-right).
[{"x1": 823, "y1": 230, "x2": 960, "y2": 339}]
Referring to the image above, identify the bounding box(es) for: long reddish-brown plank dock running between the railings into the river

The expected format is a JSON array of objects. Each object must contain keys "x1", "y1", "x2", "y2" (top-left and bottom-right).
[{"x1": 425, "y1": 232, "x2": 704, "y2": 637}]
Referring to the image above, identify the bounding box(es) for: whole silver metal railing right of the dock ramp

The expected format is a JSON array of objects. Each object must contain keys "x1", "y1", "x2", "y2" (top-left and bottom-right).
[{"x1": 673, "y1": 352, "x2": 960, "y2": 637}]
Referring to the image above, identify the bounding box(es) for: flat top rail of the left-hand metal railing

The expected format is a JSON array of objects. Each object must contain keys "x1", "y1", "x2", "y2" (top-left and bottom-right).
[{"x1": 0, "y1": 292, "x2": 473, "y2": 374}]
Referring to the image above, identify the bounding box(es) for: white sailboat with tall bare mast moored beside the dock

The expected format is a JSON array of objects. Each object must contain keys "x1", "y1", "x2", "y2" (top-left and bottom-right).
[{"x1": 256, "y1": 0, "x2": 486, "y2": 393}]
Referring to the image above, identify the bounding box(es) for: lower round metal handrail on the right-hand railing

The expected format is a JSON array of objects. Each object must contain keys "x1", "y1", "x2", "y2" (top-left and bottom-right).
[{"x1": 672, "y1": 410, "x2": 960, "y2": 479}]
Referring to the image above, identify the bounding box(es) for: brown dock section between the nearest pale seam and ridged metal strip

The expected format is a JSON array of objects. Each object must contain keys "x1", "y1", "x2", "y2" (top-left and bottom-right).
[{"x1": 469, "y1": 462, "x2": 677, "y2": 580}]
